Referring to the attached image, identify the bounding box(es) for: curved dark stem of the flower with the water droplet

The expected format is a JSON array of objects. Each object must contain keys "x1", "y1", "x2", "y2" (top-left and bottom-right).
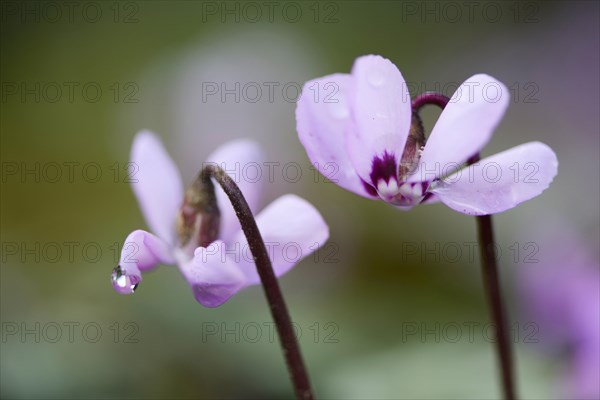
[{"x1": 201, "y1": 165, "x2": 313, "y2": 400}]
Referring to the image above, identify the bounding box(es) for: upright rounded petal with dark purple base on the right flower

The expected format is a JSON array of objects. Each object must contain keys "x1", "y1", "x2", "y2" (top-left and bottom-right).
[{"x1": 347, "y1": 55, "x2": 412, "y2": 188}]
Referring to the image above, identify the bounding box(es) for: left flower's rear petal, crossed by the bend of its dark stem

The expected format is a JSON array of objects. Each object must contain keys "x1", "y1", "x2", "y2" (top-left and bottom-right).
[{"x1": 207, "y1": 139, "x2": 263, "y2": 242}]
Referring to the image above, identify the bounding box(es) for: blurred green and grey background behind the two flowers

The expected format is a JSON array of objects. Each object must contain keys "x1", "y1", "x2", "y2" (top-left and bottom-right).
[{"x1": 0, "y1": 1, "x2": 600, "y2": 399}]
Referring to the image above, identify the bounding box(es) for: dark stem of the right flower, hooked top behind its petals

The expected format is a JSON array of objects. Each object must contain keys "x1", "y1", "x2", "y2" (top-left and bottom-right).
[{"x1": 412, "y1": 92, "x2": 516, "y2": 400}]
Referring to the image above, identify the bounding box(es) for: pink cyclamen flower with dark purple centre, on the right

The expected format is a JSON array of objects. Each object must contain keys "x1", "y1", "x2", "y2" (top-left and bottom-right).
[{"x1": 296, "y1": 55, "x2": 558, "y2": 215}]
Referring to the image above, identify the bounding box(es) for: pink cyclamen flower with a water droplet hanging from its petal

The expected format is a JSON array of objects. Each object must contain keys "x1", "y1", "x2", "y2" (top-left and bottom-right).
[{"x1": 112, "y1": 131, "x2": 329, "y2": 307}]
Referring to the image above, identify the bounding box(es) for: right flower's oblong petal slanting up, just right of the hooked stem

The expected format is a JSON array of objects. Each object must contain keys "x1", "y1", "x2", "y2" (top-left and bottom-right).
[{"x1": 409, "y1": 74, "x2": 510, "y2": 182}]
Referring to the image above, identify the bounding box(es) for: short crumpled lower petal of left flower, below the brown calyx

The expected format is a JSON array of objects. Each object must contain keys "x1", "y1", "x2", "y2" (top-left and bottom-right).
[{"x1": 179, "y1": 240, "x2": 247, "y2": 308}]
